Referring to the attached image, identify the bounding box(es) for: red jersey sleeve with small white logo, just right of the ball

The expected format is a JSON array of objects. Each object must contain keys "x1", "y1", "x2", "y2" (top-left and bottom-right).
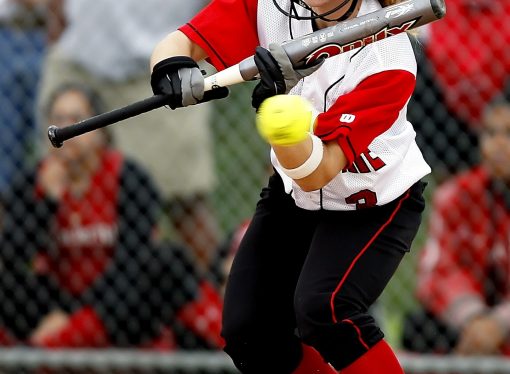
[{"x1": 314, "y1": 70, "x2": 416, "y2": 166}]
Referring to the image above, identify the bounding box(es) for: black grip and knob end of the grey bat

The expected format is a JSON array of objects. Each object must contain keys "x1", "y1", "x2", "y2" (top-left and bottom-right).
[{"x1": 48, "y1": 95, "x2": 168, "y2": 148}]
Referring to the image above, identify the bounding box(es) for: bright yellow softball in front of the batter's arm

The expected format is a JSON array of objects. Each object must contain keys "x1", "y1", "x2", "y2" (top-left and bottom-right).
[{"x1": 256, "y1": 95, "x2": 312, "y2": 145}]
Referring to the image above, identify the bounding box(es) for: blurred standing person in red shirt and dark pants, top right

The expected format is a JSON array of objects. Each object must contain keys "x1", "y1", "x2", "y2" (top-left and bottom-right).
[{"x1": 409, "y1": 0, "x2": 510, "y2": 180}]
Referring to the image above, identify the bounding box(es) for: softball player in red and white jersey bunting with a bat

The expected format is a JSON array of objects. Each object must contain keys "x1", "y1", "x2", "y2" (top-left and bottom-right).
[{"x1": 151, "y1": 0, "x2": 430, "y2": 374}]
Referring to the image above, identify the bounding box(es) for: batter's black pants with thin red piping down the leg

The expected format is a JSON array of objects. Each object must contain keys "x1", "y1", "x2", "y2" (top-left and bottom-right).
[{"x1": 223, "y1": 175, "x2": 424, "y2": 374}]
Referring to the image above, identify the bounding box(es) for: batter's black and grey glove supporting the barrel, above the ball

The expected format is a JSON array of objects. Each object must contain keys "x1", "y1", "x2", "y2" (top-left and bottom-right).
[{"x1": 251, "y1": 43, "x2": 324, "y2": 110}]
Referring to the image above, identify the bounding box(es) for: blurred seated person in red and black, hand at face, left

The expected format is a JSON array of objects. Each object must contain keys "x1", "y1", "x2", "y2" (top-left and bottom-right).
[{"x1": 0, "y1": 84, "x2": 222, "y2": 349}]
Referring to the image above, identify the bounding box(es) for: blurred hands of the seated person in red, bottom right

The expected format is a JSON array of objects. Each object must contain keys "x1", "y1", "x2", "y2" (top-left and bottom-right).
[{"x1": 455, "y1": 316, "x2": 505, "y2": 355}]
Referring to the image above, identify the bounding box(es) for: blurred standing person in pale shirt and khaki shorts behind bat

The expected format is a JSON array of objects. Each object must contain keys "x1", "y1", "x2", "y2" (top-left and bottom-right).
[{"x1": 35, "y1": 0, "x2": 219, "y2": 269}]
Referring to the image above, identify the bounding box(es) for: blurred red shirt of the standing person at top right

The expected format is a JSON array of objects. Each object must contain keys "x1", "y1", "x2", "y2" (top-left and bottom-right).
[{"x1": 426, "y1": 0, "x2": 510, "y2": 128}]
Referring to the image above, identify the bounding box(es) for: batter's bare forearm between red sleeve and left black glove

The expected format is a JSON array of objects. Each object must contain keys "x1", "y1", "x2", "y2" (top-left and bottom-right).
[{"x1": 150, "y1": 30, "x2": 207, "y2": 71}]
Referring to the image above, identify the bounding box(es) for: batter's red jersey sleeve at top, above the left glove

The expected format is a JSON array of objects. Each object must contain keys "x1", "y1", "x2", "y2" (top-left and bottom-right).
[{"x1": 179, "y1": 0, "x2": 259, "y2": 71}]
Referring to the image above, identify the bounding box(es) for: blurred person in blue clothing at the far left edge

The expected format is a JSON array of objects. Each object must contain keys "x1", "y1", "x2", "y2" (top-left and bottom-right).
[{"x1": 0, "y1": 0, "x2": 46, "y2": 191}]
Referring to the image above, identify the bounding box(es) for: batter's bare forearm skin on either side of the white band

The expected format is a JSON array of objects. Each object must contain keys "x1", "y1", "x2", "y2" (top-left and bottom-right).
[{"x1": 273, "y1": 138, "x2": 347, "y2": 191}]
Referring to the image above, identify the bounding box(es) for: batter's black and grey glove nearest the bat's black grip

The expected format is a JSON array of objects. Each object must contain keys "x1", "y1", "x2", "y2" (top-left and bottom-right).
[{"x1": 151, "y1": 56, "x2": 229, "y2": 109}]
